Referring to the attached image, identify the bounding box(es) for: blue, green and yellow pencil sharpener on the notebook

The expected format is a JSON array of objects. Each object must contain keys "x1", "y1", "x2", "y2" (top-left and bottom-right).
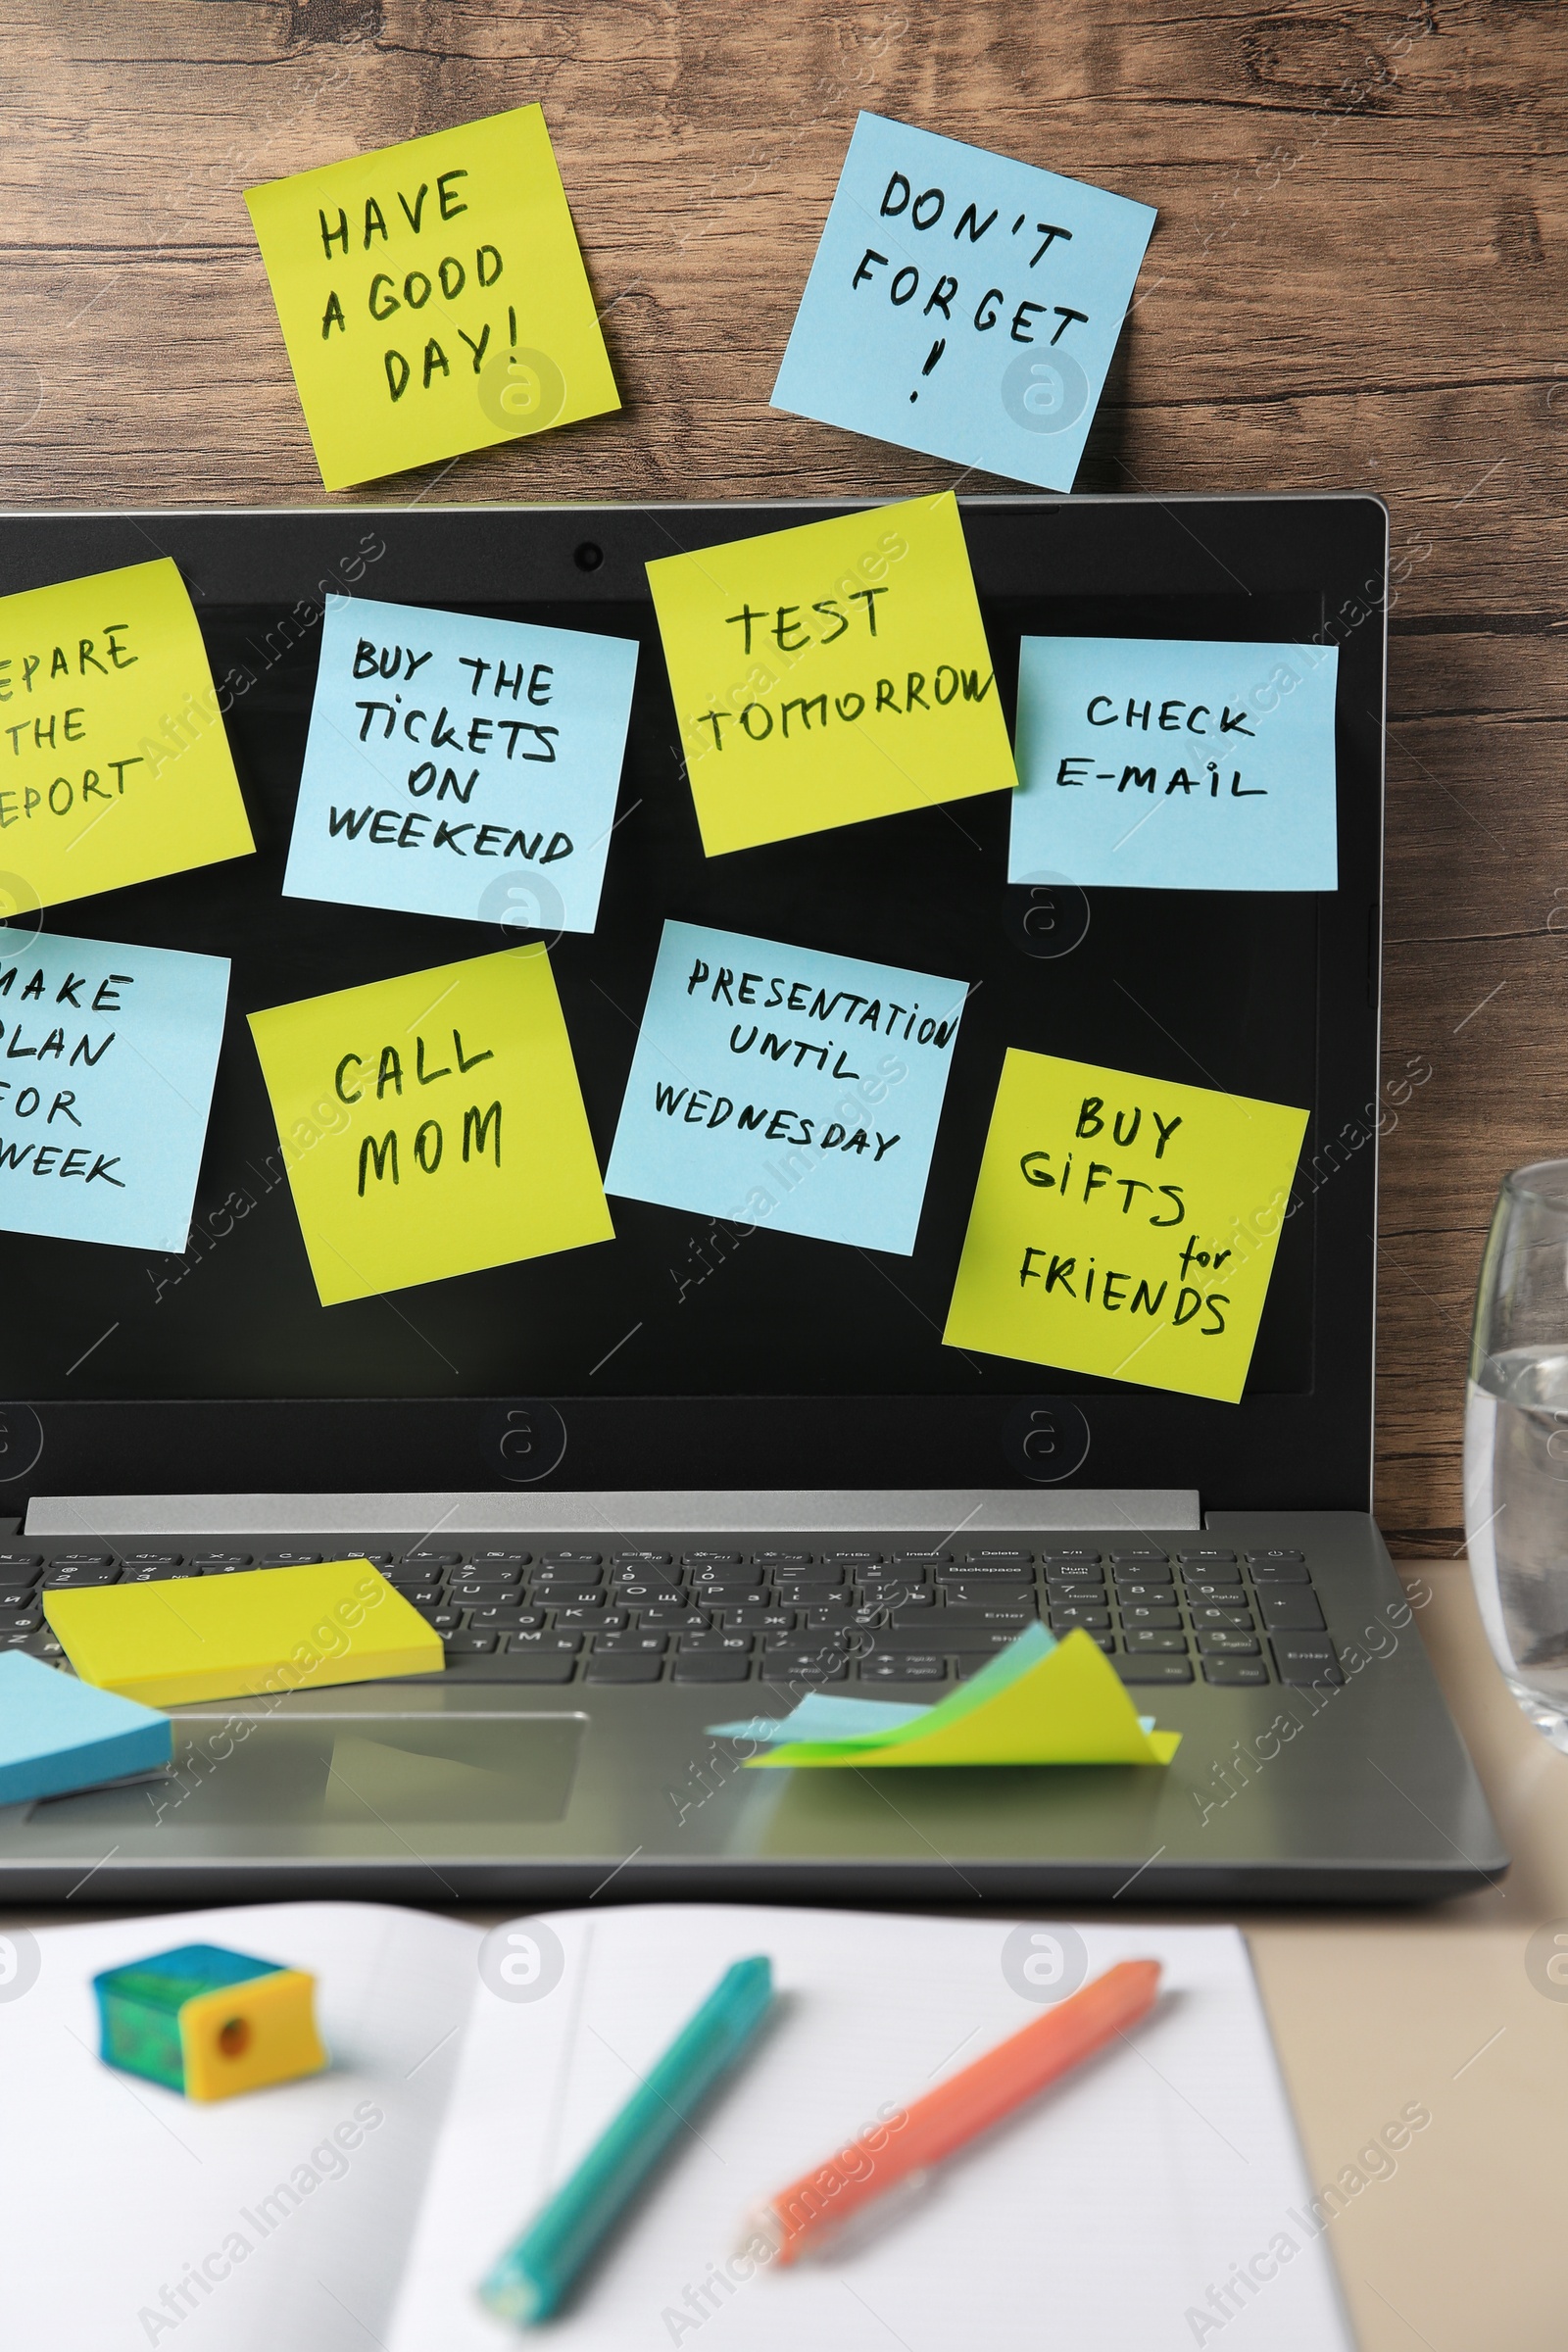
[{"x1": 92, "y1": 1942, "x2": 326, "y2": 2100}]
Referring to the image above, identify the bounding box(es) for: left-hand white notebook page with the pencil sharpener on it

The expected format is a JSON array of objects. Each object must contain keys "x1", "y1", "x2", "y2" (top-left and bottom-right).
[{"x1": 0, "y1": 1903, "x2": 479, "y2": 2352}]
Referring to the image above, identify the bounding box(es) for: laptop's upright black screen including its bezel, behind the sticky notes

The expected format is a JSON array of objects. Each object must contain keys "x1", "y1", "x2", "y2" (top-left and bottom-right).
[{"x1": 0, "y1": 501, "x2": 1382, "y2": 1500}]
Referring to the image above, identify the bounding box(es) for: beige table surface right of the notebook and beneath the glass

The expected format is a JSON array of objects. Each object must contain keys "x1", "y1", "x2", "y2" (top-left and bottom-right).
[{"x1": 0, "y1": 1562, "x2": 1568, "y2": 2352}]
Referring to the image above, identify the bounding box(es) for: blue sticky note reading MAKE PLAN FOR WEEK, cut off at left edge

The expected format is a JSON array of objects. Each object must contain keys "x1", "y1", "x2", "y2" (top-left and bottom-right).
[{"x1": 0, "y1": 929, "x2": 228, "y2": 1251}]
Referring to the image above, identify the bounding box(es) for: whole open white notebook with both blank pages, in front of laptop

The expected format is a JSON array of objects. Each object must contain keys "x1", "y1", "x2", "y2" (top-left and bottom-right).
[{"x1": 0, "y1": 1903, "x2": 1351, "y2": 2352}]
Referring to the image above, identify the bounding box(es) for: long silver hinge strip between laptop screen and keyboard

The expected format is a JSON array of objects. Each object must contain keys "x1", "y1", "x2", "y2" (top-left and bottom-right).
[{"x1": 25, "y1": 1487, "x2": 1203, "y2": 1543}]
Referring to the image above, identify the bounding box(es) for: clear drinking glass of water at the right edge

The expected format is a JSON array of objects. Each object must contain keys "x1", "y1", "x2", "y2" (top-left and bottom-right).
[{"x1": 1464, "y1": 1159, "x2": 1568, "y2": 1752}]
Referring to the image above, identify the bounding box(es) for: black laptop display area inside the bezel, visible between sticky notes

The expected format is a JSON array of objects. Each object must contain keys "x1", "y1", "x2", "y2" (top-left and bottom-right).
[{"x1": 12, "y1": 581, "x2": 1319, "y2": 1397}]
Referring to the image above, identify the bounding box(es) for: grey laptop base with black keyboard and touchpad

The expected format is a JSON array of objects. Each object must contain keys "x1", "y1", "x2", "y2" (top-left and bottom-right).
[{"x1": 0, "y1": 1494, "x2": 1507, "y2": 1907}]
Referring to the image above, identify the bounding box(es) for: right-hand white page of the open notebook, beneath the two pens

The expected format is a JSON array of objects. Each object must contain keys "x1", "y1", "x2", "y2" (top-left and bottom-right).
[{"x1": 388, "y1": 1905, "x2": 1349, "y2": 2352}]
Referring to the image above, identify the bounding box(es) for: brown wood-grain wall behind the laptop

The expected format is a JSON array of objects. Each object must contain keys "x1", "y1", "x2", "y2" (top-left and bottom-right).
[{"x1": 0, "y1": 0, "x2": 1568, "y2": 1552}]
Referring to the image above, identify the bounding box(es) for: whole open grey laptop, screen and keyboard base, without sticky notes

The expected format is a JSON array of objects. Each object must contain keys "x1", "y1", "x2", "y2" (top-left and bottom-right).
[{"x1": 0, "y1": 496, "x2": 1507, "y2": 1905}]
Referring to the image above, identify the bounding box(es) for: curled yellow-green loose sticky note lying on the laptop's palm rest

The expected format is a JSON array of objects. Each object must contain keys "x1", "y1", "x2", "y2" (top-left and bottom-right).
[{"x1": 750, "y1": 1625, "x2": 1180, "y2": 1769}]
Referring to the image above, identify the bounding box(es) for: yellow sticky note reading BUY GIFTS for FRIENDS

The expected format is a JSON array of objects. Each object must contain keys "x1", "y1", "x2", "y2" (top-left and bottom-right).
[{"x1": 943, "y1": 1049, "x2": 1307, "y2": 1404}]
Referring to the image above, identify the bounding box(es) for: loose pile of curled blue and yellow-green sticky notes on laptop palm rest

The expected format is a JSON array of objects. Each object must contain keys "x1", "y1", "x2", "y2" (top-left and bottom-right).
[{"x1": 710, "y1": 1625, "x2": 1180, "y2": 1766}]
